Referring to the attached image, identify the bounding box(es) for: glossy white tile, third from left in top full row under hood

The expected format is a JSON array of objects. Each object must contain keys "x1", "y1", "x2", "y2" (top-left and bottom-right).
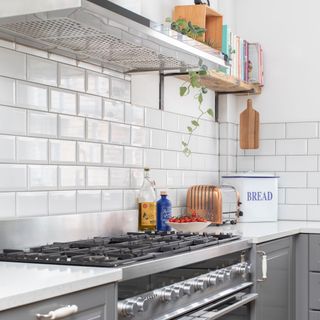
[{"x1": 59, "y1": 64, "x2": 85, "y2": 91}]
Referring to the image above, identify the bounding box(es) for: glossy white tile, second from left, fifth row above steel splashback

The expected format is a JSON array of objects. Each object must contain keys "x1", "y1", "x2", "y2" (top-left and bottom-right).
[{"x1": 17, "y1": 81, "x2": 48, "y2": 111}]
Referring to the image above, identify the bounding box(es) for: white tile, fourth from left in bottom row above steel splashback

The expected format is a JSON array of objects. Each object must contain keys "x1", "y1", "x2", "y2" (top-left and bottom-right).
[{"x1": 77, "y1": 190, "x2": 101, "y2": 213}]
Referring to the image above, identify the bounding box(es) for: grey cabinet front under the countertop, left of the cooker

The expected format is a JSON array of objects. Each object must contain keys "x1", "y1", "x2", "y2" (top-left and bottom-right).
[{"x1": 0, "y1": 284, "x2": 117, "y2": 320}]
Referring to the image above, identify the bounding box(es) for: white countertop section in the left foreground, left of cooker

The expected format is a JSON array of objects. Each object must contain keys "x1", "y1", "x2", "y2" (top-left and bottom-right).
[{"x1": 0, "y1": 262, "x2": 122, "y2": 312}]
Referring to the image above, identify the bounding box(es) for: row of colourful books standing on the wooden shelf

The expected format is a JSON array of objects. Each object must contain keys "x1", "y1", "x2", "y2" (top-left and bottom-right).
[{"x1": 222, "y1": 25, "x2": 264, "y2": 86}]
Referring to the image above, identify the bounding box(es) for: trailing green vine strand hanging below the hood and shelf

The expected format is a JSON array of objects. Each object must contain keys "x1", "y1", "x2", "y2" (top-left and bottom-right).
[{"x1": 179, "y1": 61, "x2": 214, "y2": 157}]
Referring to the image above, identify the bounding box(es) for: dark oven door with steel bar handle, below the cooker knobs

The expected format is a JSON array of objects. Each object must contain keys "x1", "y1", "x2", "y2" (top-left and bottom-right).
[{"x1": 175, "y1": 292, "x2": 258, "y2": 320}]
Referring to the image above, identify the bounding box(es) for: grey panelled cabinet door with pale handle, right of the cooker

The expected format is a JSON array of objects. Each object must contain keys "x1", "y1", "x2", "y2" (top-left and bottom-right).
[{"x1": 256, "y1": 238, "x2": 294, "y2": 320}]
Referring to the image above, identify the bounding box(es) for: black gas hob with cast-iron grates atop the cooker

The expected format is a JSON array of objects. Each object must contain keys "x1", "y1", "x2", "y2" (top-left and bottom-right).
[{"x1": 0, "y1": 232, "x2": 240, "y2": 267}]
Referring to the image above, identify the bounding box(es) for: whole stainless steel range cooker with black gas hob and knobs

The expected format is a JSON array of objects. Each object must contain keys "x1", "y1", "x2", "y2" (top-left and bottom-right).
[{"x1": 0, "y1": 232, "x2": 257, "y2": 320}]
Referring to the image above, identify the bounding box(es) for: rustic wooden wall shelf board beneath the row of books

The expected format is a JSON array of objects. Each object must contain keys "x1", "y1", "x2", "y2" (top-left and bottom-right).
[{"x1": 179, "y1": 70, "x2": 261, "y2": 95}]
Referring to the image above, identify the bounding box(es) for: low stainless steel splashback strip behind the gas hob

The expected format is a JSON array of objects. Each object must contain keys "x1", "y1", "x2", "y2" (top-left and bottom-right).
[{"x1": 0, "y1": 210, "x2": 138, "y2": 250}]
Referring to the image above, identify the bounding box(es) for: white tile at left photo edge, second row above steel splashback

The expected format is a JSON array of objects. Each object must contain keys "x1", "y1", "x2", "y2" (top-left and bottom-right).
[{"x1": 0, "y1": 164, "x2": 27, "y2": 191}]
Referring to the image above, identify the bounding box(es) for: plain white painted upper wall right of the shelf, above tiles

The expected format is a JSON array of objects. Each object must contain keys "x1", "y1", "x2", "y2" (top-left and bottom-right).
[{"x1": 233, "y1": 0, "x2": 320, "y2": 122}]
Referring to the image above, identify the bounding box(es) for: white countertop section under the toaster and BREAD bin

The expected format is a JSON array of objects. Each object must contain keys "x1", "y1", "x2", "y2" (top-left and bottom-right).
[{"x1": 205, "y1": 221, "x2": 320, "y2": 243}]
